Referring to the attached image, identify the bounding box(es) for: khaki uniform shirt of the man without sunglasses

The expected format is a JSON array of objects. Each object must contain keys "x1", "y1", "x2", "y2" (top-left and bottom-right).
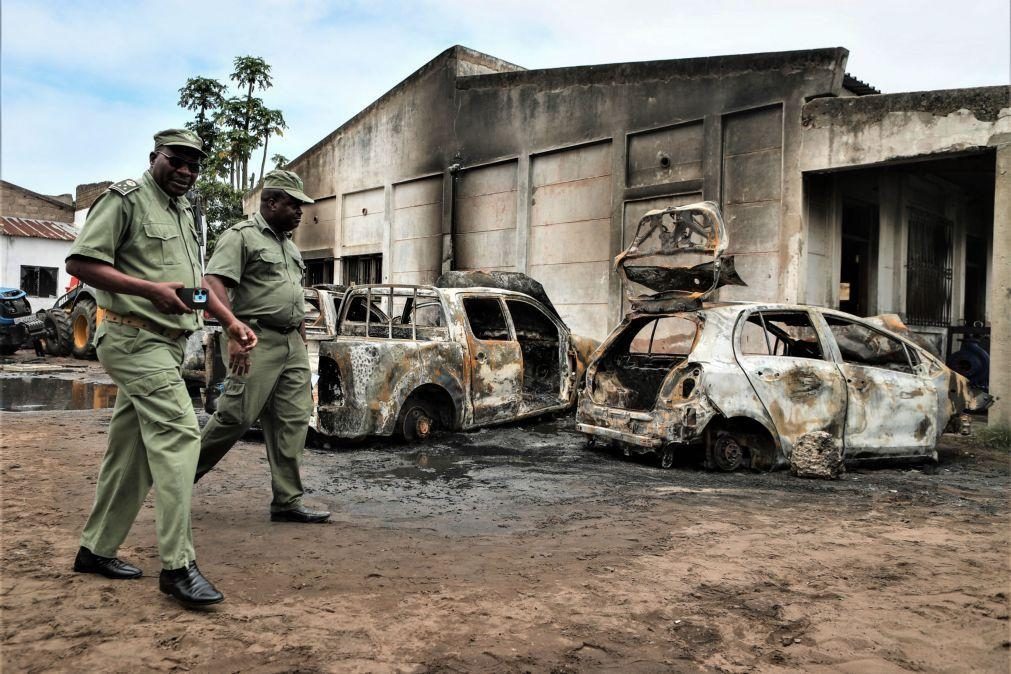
[{"x1": 207, "y1": 213, "x2": 305, "y2": 329}]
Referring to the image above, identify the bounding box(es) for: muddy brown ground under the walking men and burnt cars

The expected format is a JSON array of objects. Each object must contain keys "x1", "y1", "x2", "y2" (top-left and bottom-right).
[{"x1": 0, "y1": 359, "x2": 1011, "y2": 672}]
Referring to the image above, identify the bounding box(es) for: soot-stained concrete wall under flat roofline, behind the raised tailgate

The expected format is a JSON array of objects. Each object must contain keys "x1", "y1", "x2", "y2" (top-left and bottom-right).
[{"x1": 456, "y1": 50, "x2": 846, "y2": 338}]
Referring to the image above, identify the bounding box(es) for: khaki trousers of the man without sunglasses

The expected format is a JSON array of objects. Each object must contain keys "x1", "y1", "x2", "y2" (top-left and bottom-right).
[{"x1": 196, "y1": 321, "x2": 312, "y2": 512}]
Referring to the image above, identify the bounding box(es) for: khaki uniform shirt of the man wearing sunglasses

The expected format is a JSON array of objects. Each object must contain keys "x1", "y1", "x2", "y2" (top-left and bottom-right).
[{"x1": 67, "y1": 171, "x2": 202, "y2": 330}]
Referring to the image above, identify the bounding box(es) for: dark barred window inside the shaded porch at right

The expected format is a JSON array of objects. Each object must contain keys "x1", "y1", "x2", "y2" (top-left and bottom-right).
[{"x1": 906, "y1": 208, "x2": 952, "y2": 326}]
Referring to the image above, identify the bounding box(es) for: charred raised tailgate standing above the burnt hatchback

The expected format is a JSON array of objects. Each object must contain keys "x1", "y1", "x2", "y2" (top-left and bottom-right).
[{"x1": 615, "y1": 201, "x2": 747, "y2": 312}]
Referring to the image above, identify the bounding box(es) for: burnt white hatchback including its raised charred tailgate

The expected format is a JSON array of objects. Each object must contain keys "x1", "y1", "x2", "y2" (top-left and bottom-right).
[{"x1": 576, "y1": 202, "x2": 989, "y2": 471}]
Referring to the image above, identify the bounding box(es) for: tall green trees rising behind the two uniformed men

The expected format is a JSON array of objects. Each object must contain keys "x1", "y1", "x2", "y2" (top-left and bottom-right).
[{"x1": 179, "y1": 56, "x2": 288, "y2": 249}]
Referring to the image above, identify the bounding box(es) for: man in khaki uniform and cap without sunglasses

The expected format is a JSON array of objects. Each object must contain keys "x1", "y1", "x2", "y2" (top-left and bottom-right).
[{"x1": 196, "y1": 171, "x2": 330, "y2": 522}]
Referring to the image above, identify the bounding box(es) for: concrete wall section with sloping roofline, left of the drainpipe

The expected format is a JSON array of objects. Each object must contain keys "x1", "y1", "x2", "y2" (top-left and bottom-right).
[{"x1": 244, "y1": 46, "x2": 518, "y2": 281}]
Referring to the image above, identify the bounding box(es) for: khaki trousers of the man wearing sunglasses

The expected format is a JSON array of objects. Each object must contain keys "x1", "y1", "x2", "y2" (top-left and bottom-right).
[{"x1": 81, "y1": 321, "x2": 200, "y2": 569}]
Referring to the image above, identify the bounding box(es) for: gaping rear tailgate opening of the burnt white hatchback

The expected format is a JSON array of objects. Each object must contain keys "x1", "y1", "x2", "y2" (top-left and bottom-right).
[{"x1": 590, "y1": 316, "x2": 699, "y2": 410}]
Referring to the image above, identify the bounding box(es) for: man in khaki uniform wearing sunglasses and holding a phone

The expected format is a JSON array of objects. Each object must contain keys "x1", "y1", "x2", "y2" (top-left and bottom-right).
[{"x1": 67, "y1": 129, "x2": 256, "y2": 606}]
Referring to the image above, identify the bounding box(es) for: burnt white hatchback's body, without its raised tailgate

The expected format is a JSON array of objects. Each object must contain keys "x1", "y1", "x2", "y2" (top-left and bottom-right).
[{"x1": 576, "y1": 303, "x2": 988, "y2": 470}]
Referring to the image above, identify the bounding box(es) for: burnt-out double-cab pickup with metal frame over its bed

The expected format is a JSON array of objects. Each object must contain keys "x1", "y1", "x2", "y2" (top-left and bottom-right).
[{"x1": 312, "y1": 275, "x2": 595, "y2": 441}]
